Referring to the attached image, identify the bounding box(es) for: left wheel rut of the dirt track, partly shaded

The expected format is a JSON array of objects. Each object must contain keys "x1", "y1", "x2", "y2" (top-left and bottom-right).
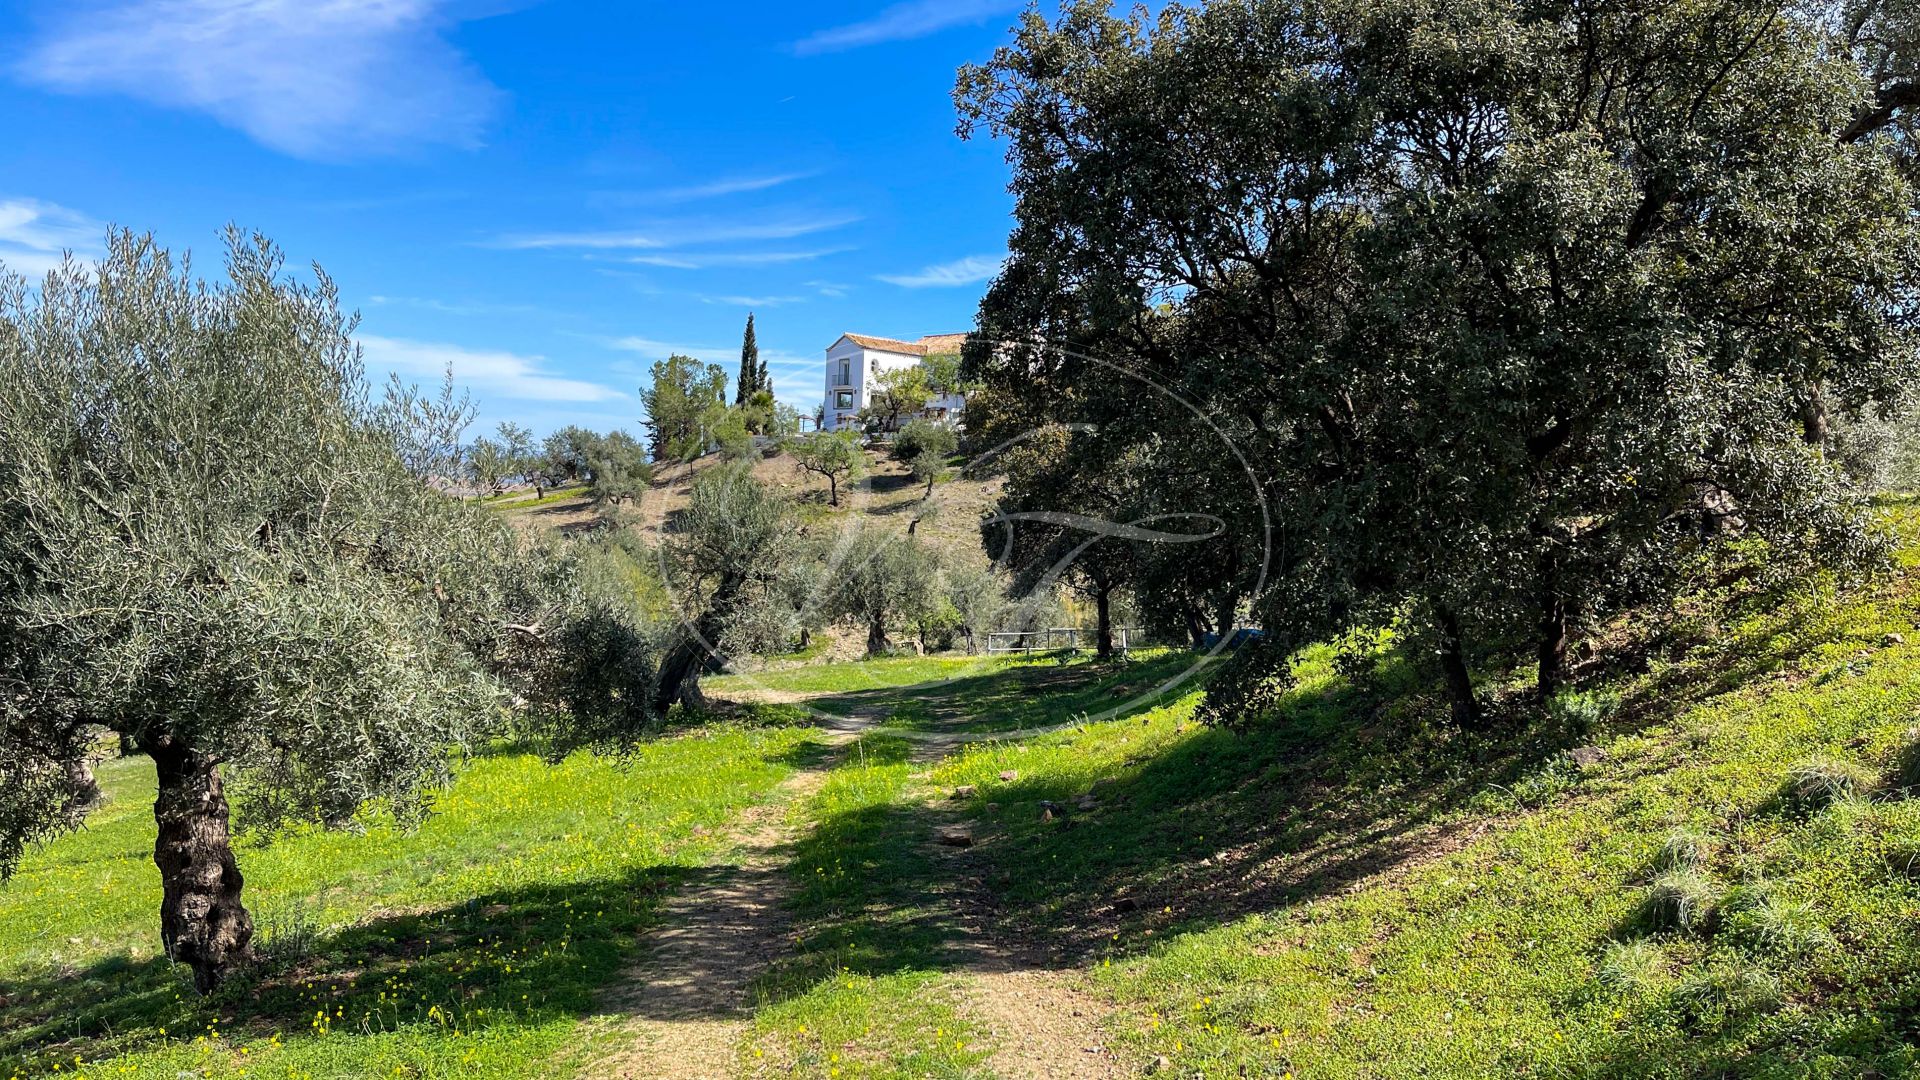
[{"x1": 584, "y1": 730, "x2": 856, "y2": 1080}]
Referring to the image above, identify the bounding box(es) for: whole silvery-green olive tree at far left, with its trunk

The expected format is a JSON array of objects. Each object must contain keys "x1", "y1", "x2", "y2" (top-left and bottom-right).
[{"x1": 0, "y1": 233, "x2": 660, "y2": 990}]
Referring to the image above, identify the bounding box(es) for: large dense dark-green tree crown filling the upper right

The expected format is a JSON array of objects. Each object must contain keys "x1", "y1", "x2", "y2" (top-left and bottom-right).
[{"x1": 956, "y1": 0, "x2": 1916, "y2": 723}]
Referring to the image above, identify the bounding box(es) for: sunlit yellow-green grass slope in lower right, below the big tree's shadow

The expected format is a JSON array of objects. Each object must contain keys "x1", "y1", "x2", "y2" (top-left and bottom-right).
[{"x1": 1043, "y1": 564, "x2": 1920, "y2": 1076}]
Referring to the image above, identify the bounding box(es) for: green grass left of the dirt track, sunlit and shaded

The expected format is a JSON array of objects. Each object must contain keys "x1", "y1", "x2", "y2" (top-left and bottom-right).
[{"x1": 0, "y1": 728, "x2": 808, "y2": 1080}]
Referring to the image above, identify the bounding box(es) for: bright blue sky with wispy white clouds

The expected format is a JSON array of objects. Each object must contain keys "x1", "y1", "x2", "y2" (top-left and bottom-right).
[{"x1": 0, "y1": 0, "x2": 1021, "y2": 432}]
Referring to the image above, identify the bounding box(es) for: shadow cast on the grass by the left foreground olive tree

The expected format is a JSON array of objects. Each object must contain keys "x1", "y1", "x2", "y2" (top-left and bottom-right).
[{"x1": 0, "y1": 865, "x2": 720, "y2": 1076}]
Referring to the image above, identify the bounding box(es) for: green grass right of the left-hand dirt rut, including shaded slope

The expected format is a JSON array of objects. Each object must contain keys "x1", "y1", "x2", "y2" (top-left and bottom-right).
[{"x1": 710, "y1": 526, "x2": 1920, "y2": 1078}]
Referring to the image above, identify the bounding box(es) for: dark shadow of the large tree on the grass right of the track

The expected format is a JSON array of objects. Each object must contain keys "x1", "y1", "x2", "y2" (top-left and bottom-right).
[{"x1": 940, "y1": 668, "x2": 1582, "y2": 961}]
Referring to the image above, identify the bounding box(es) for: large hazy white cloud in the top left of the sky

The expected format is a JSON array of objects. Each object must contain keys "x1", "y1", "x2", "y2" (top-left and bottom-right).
[{"x1": 13, "y1": 0, "x2": 499, "y2": 160}]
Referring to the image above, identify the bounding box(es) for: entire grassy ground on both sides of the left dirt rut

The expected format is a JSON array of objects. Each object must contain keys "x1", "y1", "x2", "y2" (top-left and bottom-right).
[{"x1": 15, "y1": 509, "x2": 1920, "y2": 1078}]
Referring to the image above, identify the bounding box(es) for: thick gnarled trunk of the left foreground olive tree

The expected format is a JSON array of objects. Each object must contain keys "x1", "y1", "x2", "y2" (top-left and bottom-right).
[{"x1": 142, "y1": 734, "x2": 253, "y2": 994}]
